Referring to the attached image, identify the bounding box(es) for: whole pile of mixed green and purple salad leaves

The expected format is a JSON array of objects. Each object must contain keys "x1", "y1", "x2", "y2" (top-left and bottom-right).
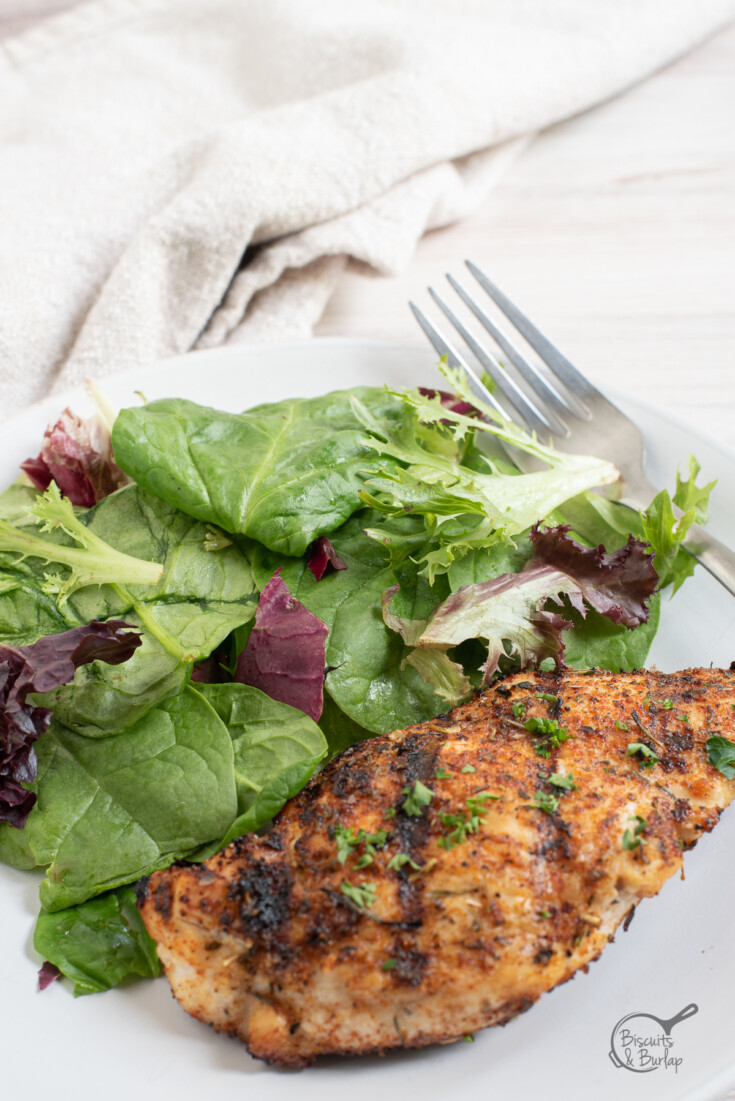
[{"x1": 0, "y1": 364, "x2": 712, "y2": 993}]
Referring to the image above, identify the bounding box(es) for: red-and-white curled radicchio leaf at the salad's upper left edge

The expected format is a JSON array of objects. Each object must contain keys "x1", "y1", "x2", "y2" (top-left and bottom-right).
[{"x1": 21, "y1": 408, "x2": 129, "y2": 509}]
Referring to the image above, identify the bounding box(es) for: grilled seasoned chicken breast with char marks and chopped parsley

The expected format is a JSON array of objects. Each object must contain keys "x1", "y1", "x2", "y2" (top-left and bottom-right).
[{"x1": 141, "y1": 669, "x2": 735, "y2": 1067}]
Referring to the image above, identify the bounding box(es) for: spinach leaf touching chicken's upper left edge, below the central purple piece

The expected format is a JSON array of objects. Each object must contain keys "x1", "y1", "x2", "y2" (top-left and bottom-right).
[{"x1": 199, "y1": 684, "x2": 327, "y2": 844}]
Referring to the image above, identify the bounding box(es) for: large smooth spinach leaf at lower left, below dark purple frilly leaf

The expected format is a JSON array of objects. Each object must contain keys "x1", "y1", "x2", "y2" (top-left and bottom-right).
[{"x1": 0, "y1": 687, "x2": 238, "y2": 911}]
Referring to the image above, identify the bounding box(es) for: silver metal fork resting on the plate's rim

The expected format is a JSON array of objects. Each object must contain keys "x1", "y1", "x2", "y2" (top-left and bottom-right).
[{"x1": 409, "y1": 260, "x2": 735, "y2": 596}]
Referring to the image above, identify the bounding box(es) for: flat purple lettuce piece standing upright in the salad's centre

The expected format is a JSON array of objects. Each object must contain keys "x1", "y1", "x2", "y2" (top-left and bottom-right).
[{"x1": 234, "y1": 568, "x2": 329, "y2": 722}]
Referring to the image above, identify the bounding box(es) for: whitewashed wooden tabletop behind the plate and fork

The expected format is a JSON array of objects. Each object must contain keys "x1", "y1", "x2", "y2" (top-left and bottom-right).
[{"x1": 0, "y1": 0, "x2": 735, "y2": 458}]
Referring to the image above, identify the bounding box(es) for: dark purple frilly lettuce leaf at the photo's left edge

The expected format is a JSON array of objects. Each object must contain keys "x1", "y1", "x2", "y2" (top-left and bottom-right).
[{"x1": 0, "y1": 620, "x2": 141, "y2": 829}]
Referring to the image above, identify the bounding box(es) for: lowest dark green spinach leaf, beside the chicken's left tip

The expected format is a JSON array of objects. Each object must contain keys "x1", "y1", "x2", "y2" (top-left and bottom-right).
[{"x1": 33, "y1": 886, "x2": 161, "y2": 998}]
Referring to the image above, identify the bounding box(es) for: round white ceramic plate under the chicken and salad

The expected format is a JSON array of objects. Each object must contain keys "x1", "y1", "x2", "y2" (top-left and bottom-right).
[{"x1": 0, "y1": 340, "x2": 735, "y2": 1101}]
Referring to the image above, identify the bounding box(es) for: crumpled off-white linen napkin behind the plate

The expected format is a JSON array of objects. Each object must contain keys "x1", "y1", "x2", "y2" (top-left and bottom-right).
[{"x1": 0, "y1": 0, "x2": 735, "y2": 414}]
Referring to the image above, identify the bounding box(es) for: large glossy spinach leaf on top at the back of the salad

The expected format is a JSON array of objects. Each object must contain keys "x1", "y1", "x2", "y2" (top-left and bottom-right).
[{"x1": 112, "y1": 388, "x2": 401, "y2": 555}]
